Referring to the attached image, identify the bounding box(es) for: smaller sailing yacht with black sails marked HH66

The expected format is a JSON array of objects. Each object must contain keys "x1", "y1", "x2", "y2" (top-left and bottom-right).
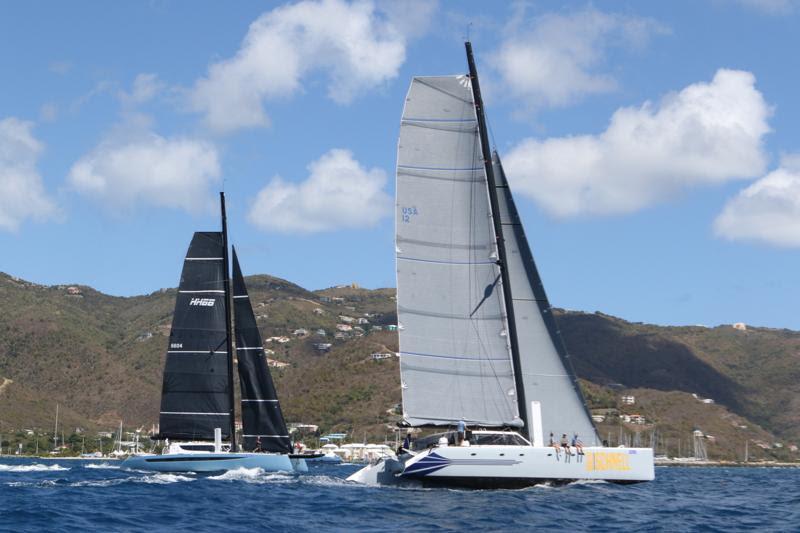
[{"x1": 122, "y1": 193, "x2": 307, "y2": 472}]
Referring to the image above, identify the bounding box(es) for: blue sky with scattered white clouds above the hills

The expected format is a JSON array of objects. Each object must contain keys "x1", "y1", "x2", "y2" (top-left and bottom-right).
[{"x1": 0, "y1": 0, "x2": 800, "y2": 329}]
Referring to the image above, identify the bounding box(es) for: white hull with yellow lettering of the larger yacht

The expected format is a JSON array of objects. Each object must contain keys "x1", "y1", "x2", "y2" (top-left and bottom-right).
[{"x1": 348, "y1": 446, "x2": 655, "y2": 488}]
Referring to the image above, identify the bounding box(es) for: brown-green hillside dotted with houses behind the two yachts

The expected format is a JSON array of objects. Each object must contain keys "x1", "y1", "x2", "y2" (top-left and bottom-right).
[{"x1": 0, "y1": 274, "x2": 800, "y2": 458}]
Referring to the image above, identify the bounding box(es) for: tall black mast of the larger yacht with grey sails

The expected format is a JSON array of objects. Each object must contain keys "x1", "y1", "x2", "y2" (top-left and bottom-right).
[{"x1": 464, "y1": 41, "x2": 530, "y2": 440}]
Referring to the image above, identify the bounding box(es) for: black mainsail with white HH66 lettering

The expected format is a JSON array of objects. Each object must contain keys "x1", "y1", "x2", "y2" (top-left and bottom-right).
[{"x1": 159, "y1": 232, "x2": 232, "y2": 440}]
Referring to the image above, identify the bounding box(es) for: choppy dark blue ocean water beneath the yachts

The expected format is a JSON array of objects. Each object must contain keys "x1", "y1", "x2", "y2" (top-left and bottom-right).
[{"x1": 0, "y1": 458, "x2": 800, "y2": 532}]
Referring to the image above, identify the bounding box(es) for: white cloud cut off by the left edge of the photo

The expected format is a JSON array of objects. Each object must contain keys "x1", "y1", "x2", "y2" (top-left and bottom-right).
[{"x1": 0, "y1": 117, "x2": 56, "y2": 231}]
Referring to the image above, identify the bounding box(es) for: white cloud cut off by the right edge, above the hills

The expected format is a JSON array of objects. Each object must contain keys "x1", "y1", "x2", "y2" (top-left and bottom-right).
[{"x1": 714, "y1": 156, "x2": 800, "y2": 247}]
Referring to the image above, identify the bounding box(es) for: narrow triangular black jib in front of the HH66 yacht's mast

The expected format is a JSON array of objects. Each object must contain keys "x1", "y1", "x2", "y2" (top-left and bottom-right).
[{"x1": 233, "y1": 249, "x2": 292, "y2": 453}]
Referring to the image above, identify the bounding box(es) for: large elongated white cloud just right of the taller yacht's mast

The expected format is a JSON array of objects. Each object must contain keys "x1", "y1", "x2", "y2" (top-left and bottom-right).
[{"x1": 505, "y1": 69, "x2": 771, "y2": 217}]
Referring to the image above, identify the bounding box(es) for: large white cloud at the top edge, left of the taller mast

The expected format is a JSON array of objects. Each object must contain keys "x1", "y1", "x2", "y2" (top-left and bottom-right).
[{"x1": 189, "y1": 0, "x2": 405, "y2": 132}]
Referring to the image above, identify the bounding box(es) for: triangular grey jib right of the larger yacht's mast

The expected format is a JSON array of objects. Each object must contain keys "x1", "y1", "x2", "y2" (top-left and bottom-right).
[{"x1": 492, "y1": 152, "x2": 600, "y2": 444}]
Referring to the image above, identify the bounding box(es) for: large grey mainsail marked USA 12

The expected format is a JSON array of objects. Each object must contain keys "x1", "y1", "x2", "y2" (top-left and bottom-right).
[{"x1": 396, "y1": 76, "x2": 523, "y2": 426}]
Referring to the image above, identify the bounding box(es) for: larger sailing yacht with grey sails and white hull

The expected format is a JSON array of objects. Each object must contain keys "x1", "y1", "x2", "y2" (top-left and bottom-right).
[{"x1": 349, "y1": 42, "x2": 654, "y2": 488}]
